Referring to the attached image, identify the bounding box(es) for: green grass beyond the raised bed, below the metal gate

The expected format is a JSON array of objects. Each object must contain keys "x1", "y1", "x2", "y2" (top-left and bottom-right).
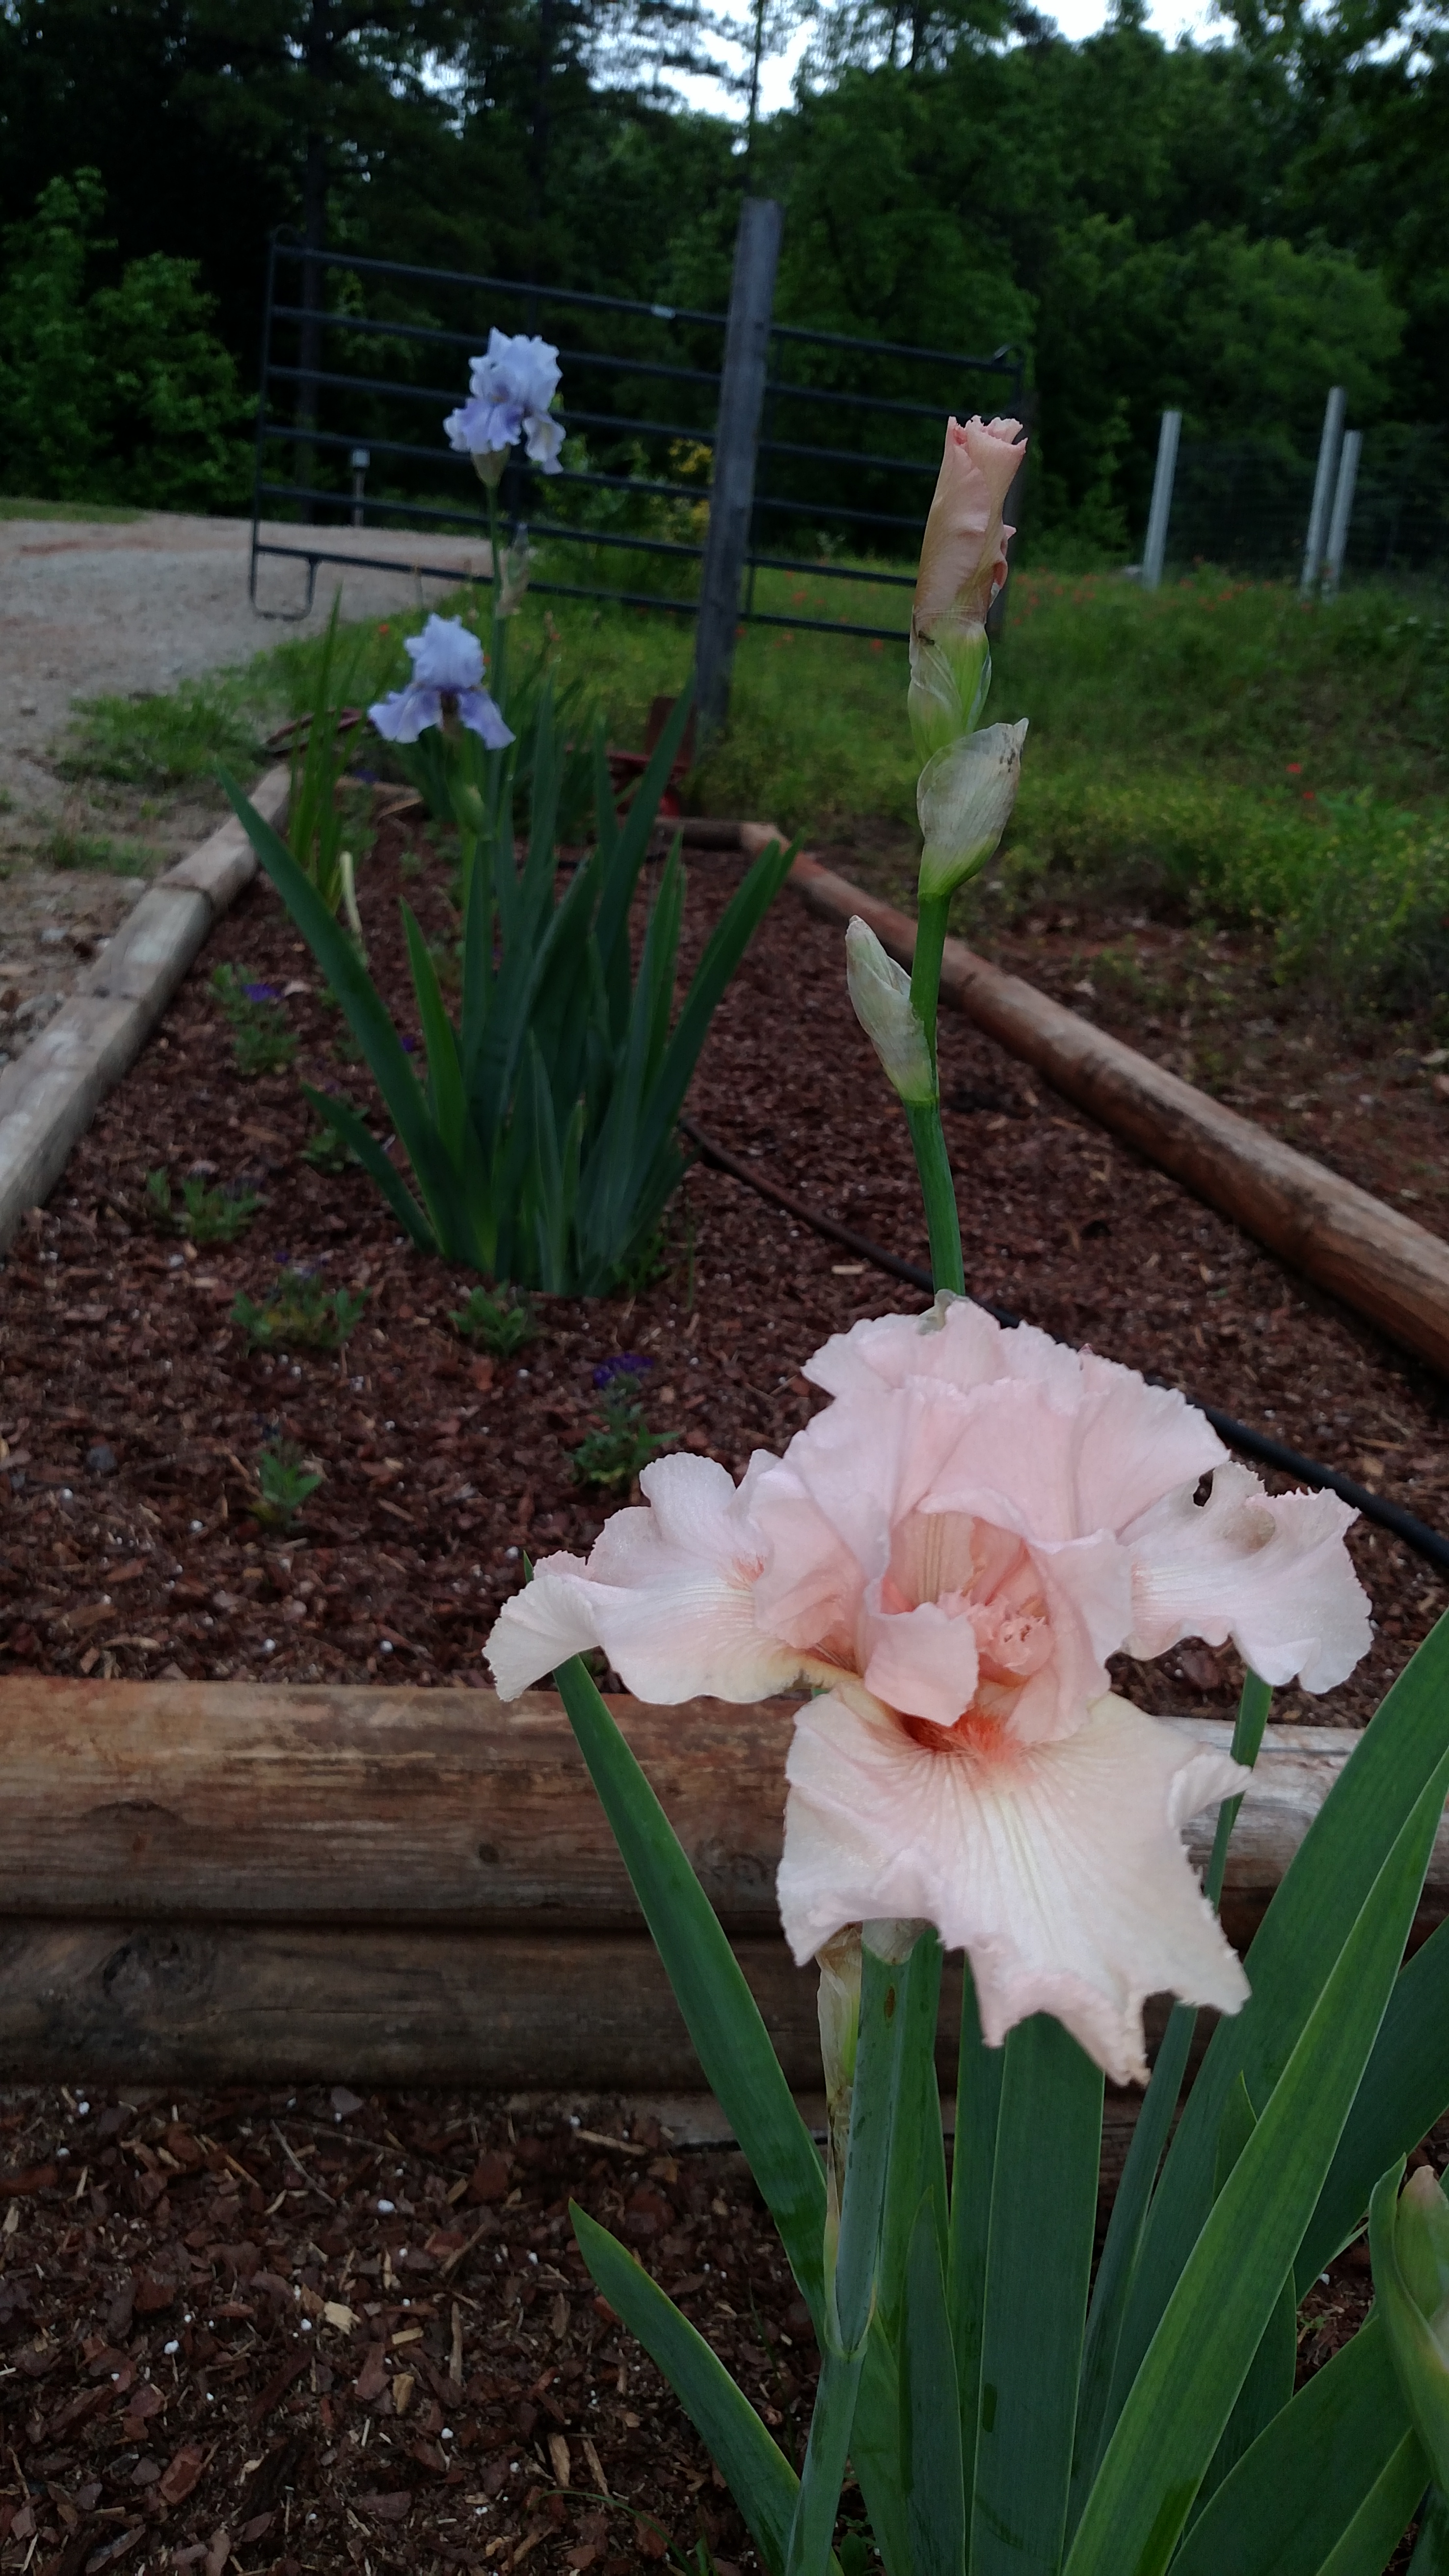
[{"x1": 48, "y1": 546, "x2": 1449, "y2": 1015}]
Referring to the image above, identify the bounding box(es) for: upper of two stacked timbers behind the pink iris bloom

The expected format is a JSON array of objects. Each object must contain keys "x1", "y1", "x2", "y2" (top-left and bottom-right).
[{"x1": 0, "y1": 1677, "x2": 1449, "y2": 1937}]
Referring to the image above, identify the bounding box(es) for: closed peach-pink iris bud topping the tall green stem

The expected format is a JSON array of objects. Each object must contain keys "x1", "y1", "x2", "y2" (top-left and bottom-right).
[{"x1": 910, "y1": 420, "x2": 1023, "y2": 760}]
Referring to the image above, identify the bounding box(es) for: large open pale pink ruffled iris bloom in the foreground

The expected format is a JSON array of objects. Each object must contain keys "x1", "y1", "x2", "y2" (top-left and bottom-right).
[{"x1": 487, "y1": 1298, "x2": 1369, "y2": 2081}]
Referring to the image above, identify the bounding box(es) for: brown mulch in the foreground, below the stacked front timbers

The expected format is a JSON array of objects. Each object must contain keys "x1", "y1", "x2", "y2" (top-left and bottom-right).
[{"x1": 0, "y1": 2087, "x2": 799, "y2": 2576}]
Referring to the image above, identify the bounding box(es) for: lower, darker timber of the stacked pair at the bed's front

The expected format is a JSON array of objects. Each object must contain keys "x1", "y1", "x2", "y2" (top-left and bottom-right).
[{"x1": 0, "y1": 1917, "x2": 830, "y2": 2092}]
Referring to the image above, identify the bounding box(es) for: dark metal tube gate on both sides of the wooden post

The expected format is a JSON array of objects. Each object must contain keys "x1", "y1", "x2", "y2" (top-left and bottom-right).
[{"x1": 250, "y1": 235, "x2": 1021, "y2": 639}]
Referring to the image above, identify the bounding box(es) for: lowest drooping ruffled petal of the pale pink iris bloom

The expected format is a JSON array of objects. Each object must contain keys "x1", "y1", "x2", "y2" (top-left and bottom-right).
[{"x1": 778, "y1": 1695, "x2": 1251, "y2": 2084}]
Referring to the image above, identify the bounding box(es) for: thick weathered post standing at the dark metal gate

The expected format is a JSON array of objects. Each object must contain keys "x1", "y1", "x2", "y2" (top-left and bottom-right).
[{"x1": 694, "y1": 196, "x2": 781, "y2": 739}]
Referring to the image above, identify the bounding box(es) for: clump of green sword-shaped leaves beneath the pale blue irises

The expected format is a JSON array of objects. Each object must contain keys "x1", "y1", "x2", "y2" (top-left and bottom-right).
[{"x1": 232, "y1": 685, "x2": 792, "y2": 1296}]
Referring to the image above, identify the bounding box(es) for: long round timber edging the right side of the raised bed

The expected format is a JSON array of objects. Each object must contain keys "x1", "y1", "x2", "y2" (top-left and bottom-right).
[{"x1": 706, "y1": 822, "x2": 1449, "y2": 1373}]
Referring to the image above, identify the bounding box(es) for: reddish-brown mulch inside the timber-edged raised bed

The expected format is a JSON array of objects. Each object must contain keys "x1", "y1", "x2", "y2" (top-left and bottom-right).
[{"x1": 0, "y1": 827, "x2": 1449, "y2": 1723}]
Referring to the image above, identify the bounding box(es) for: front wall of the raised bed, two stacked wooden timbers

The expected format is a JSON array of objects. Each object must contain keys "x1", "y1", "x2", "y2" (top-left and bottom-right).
[{"x1": 0, "y1": 1677, "x2": 1449, "y2": 2092}]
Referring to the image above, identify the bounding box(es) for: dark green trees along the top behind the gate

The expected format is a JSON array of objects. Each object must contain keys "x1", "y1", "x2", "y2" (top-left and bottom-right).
[{"x1": 0, "y1": 0, "x2": 1449, "y2": 543}]
